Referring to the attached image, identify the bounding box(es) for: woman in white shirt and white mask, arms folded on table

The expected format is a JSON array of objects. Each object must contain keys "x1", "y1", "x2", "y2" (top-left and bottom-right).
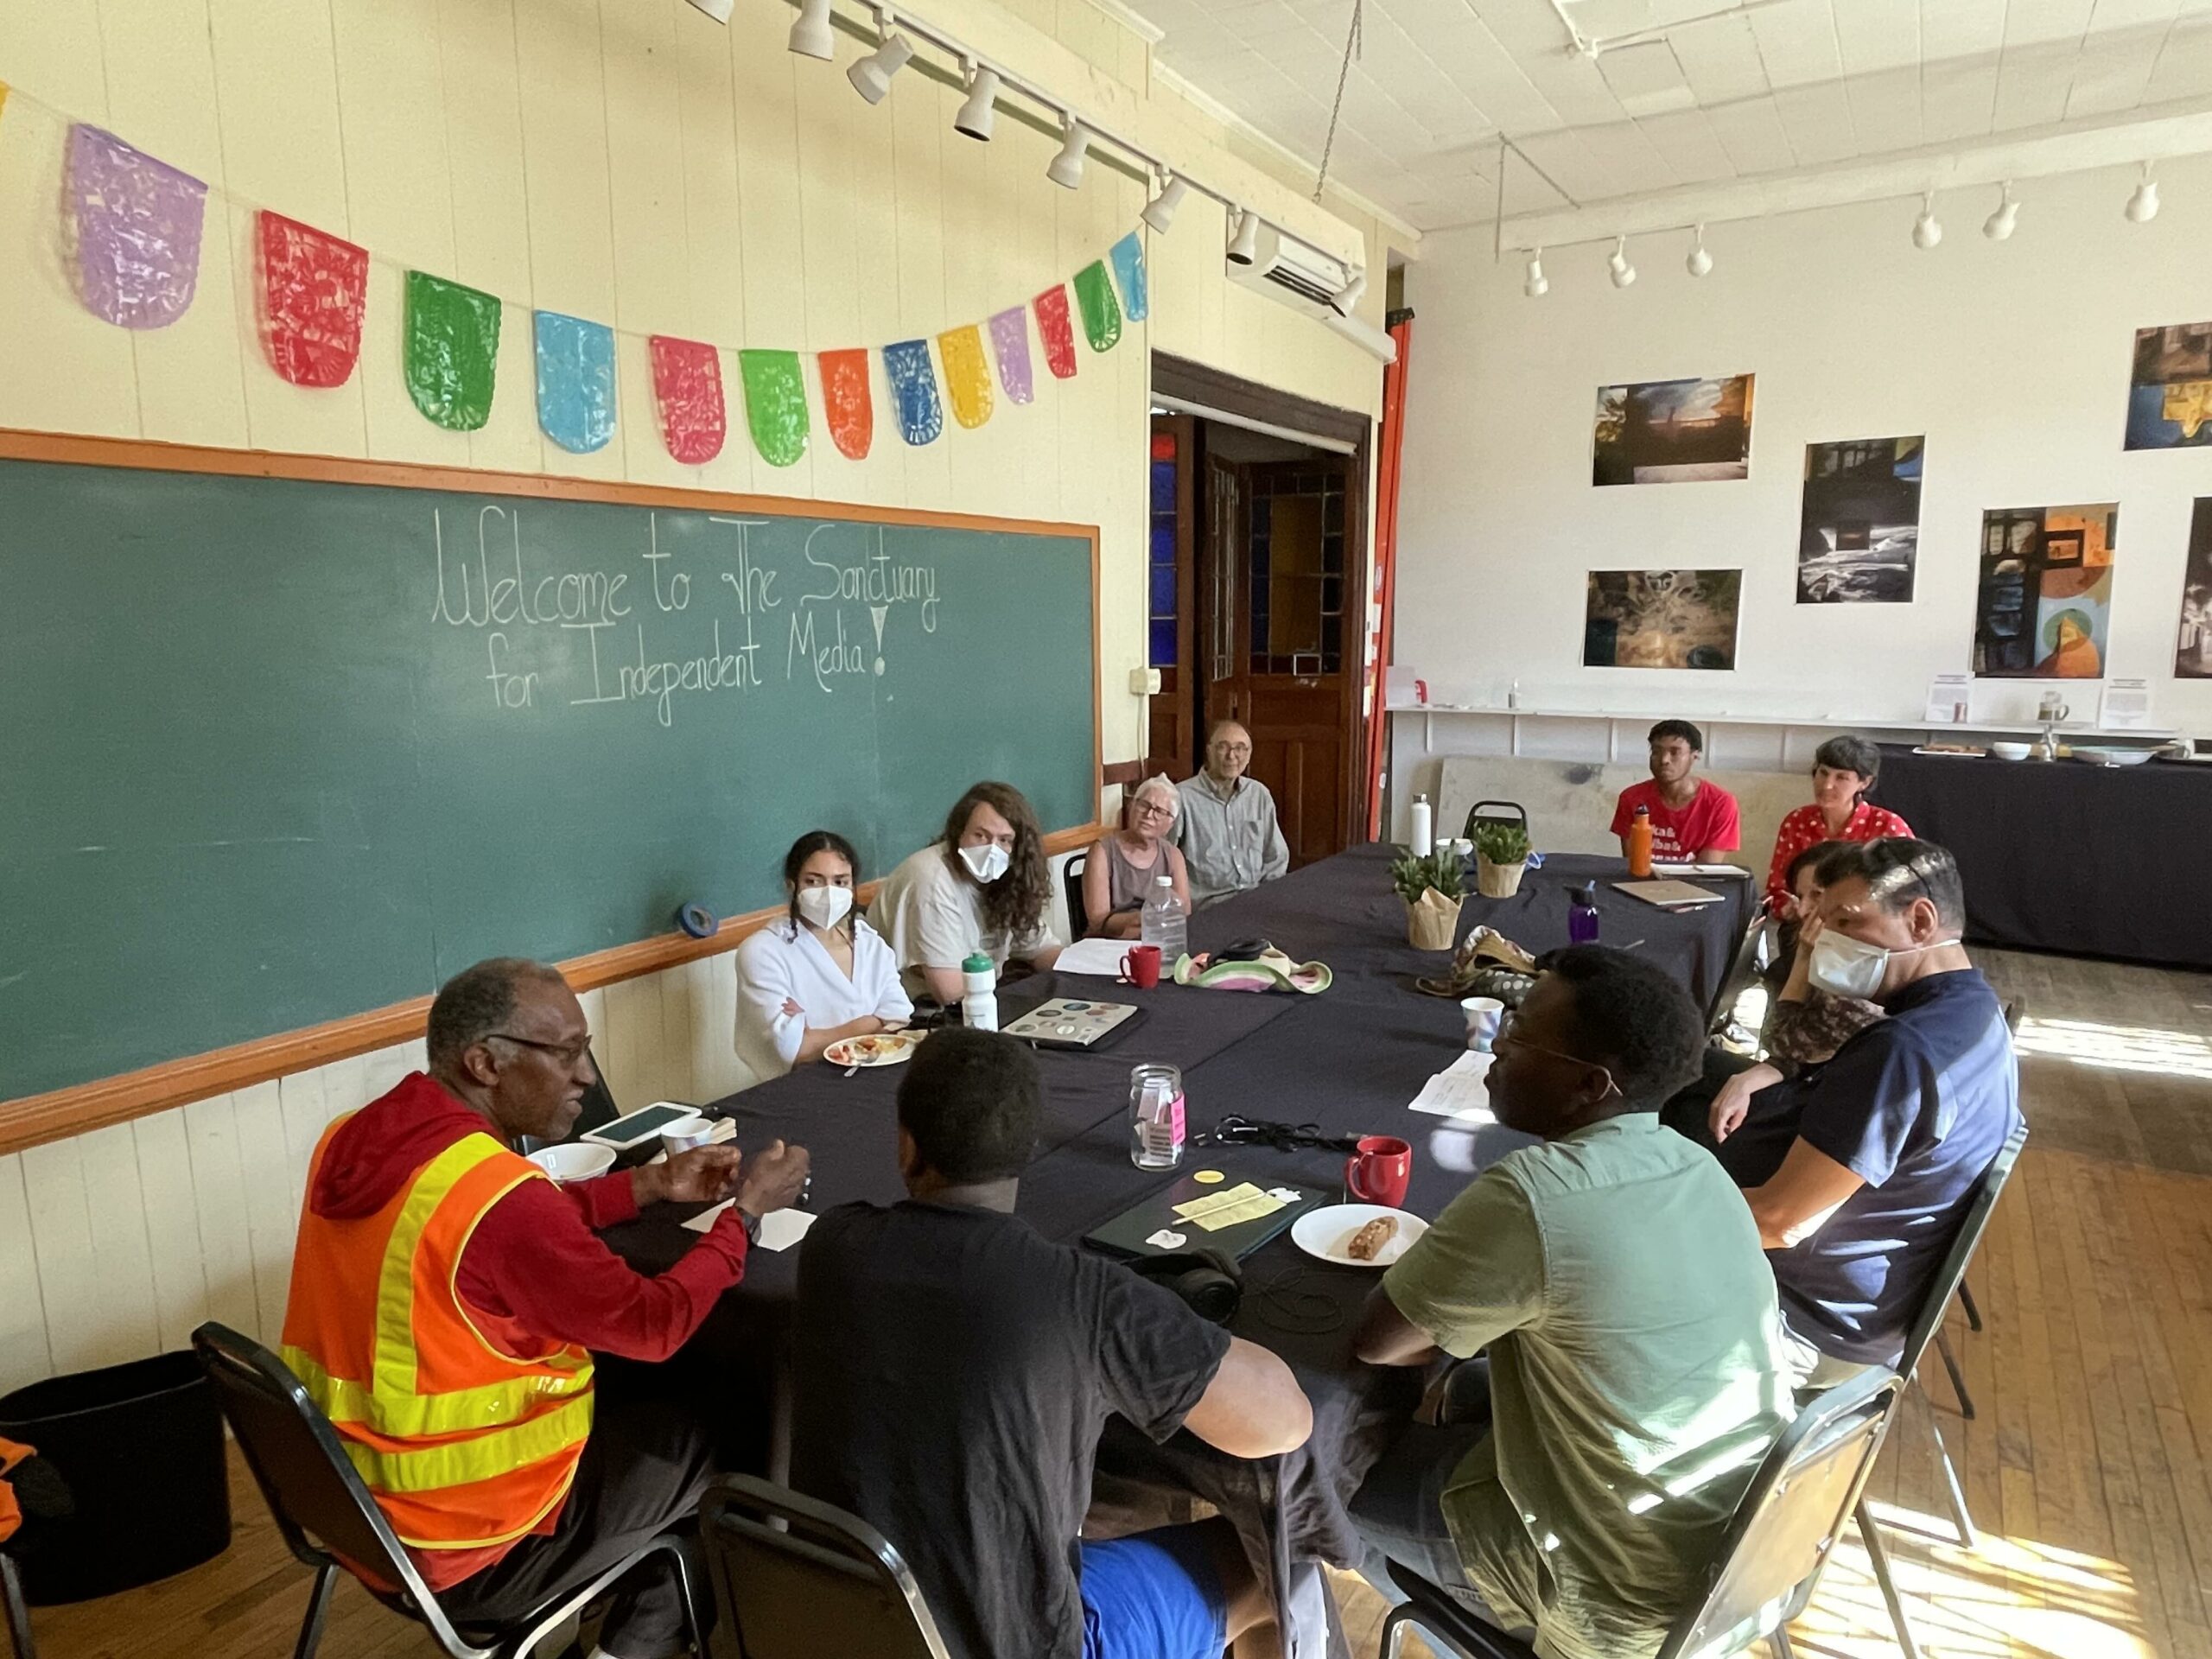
[{"x1": 736, "y1": 830, "x2": 913, "y2": 1079}]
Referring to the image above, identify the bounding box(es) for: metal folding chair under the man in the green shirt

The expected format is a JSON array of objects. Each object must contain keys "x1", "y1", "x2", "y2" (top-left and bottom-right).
[{"x1": 1380, "y1": 1371, "x2": 1904, "y2": 1659}]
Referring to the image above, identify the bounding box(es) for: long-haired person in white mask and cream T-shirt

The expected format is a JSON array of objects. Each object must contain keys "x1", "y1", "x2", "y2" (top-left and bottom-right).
[{"x1": 869, "y1": 783, "x2": 1059, "y2": 1007}]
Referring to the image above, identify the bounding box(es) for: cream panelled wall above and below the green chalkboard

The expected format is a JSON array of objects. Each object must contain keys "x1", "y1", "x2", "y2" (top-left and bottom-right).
[{"x1": 0, "y1": 0, "x2": 1385, "y2": 1389}]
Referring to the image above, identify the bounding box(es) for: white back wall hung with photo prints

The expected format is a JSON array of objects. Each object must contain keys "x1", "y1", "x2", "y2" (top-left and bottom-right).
[{"x1": 1395, "y1": 159, "x2": 2212, "y2": 732}]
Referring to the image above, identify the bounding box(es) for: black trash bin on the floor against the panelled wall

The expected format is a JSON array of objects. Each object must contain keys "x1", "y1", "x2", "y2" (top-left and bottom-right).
[{"x1": 0, "y1": 1351, "x2": 230, "y2": 1608}]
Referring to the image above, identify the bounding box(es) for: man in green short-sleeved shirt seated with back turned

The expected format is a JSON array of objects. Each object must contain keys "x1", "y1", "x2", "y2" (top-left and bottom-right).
[{"x1": 1351, "y1": 944, "x2": 1789, "y2": 1659}]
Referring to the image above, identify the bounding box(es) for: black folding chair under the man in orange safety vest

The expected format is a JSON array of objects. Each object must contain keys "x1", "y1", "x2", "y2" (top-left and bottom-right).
[{"x1": 193, "y1": 1323, "x2": 706, "y2": 1659}]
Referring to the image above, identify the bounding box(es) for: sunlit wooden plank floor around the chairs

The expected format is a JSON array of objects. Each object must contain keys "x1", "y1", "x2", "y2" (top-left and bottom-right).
[{"x1": 21, "y1": 951, "x2": 2212, "y2": 1659}]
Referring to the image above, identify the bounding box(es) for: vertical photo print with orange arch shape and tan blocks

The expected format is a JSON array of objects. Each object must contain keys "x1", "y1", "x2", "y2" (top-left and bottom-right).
[{"x1": 1974, "y1": 502, "x2": 2119, "y2": 679}]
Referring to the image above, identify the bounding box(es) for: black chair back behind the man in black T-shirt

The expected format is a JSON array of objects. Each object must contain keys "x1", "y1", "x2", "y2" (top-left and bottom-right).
[{"x1": 699, "y1": 1476, "x2": 947, "y2": 1659}]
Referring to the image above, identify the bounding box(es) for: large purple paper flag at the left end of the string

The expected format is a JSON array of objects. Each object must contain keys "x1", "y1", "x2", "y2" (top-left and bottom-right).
[{"x1": 68, "y1": 124, "x2": 208, "y2": 327}]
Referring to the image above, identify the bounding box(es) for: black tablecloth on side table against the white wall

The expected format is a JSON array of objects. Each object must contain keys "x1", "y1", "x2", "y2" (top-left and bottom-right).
[{"x1": 1873, "y1": 747, "x2": 2212, "y2": 969}]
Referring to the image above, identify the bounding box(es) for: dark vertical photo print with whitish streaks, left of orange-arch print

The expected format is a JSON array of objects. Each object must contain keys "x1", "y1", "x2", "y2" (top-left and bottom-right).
[{"x1": 1798, "y1": 438, "x2": 1924, "y2": 604}]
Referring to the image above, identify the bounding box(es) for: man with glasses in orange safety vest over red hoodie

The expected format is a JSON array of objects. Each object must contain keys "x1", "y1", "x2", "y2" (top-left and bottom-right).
[{"x1": 283, "y1": 957, "x2": 807, "y2": 1659}]
